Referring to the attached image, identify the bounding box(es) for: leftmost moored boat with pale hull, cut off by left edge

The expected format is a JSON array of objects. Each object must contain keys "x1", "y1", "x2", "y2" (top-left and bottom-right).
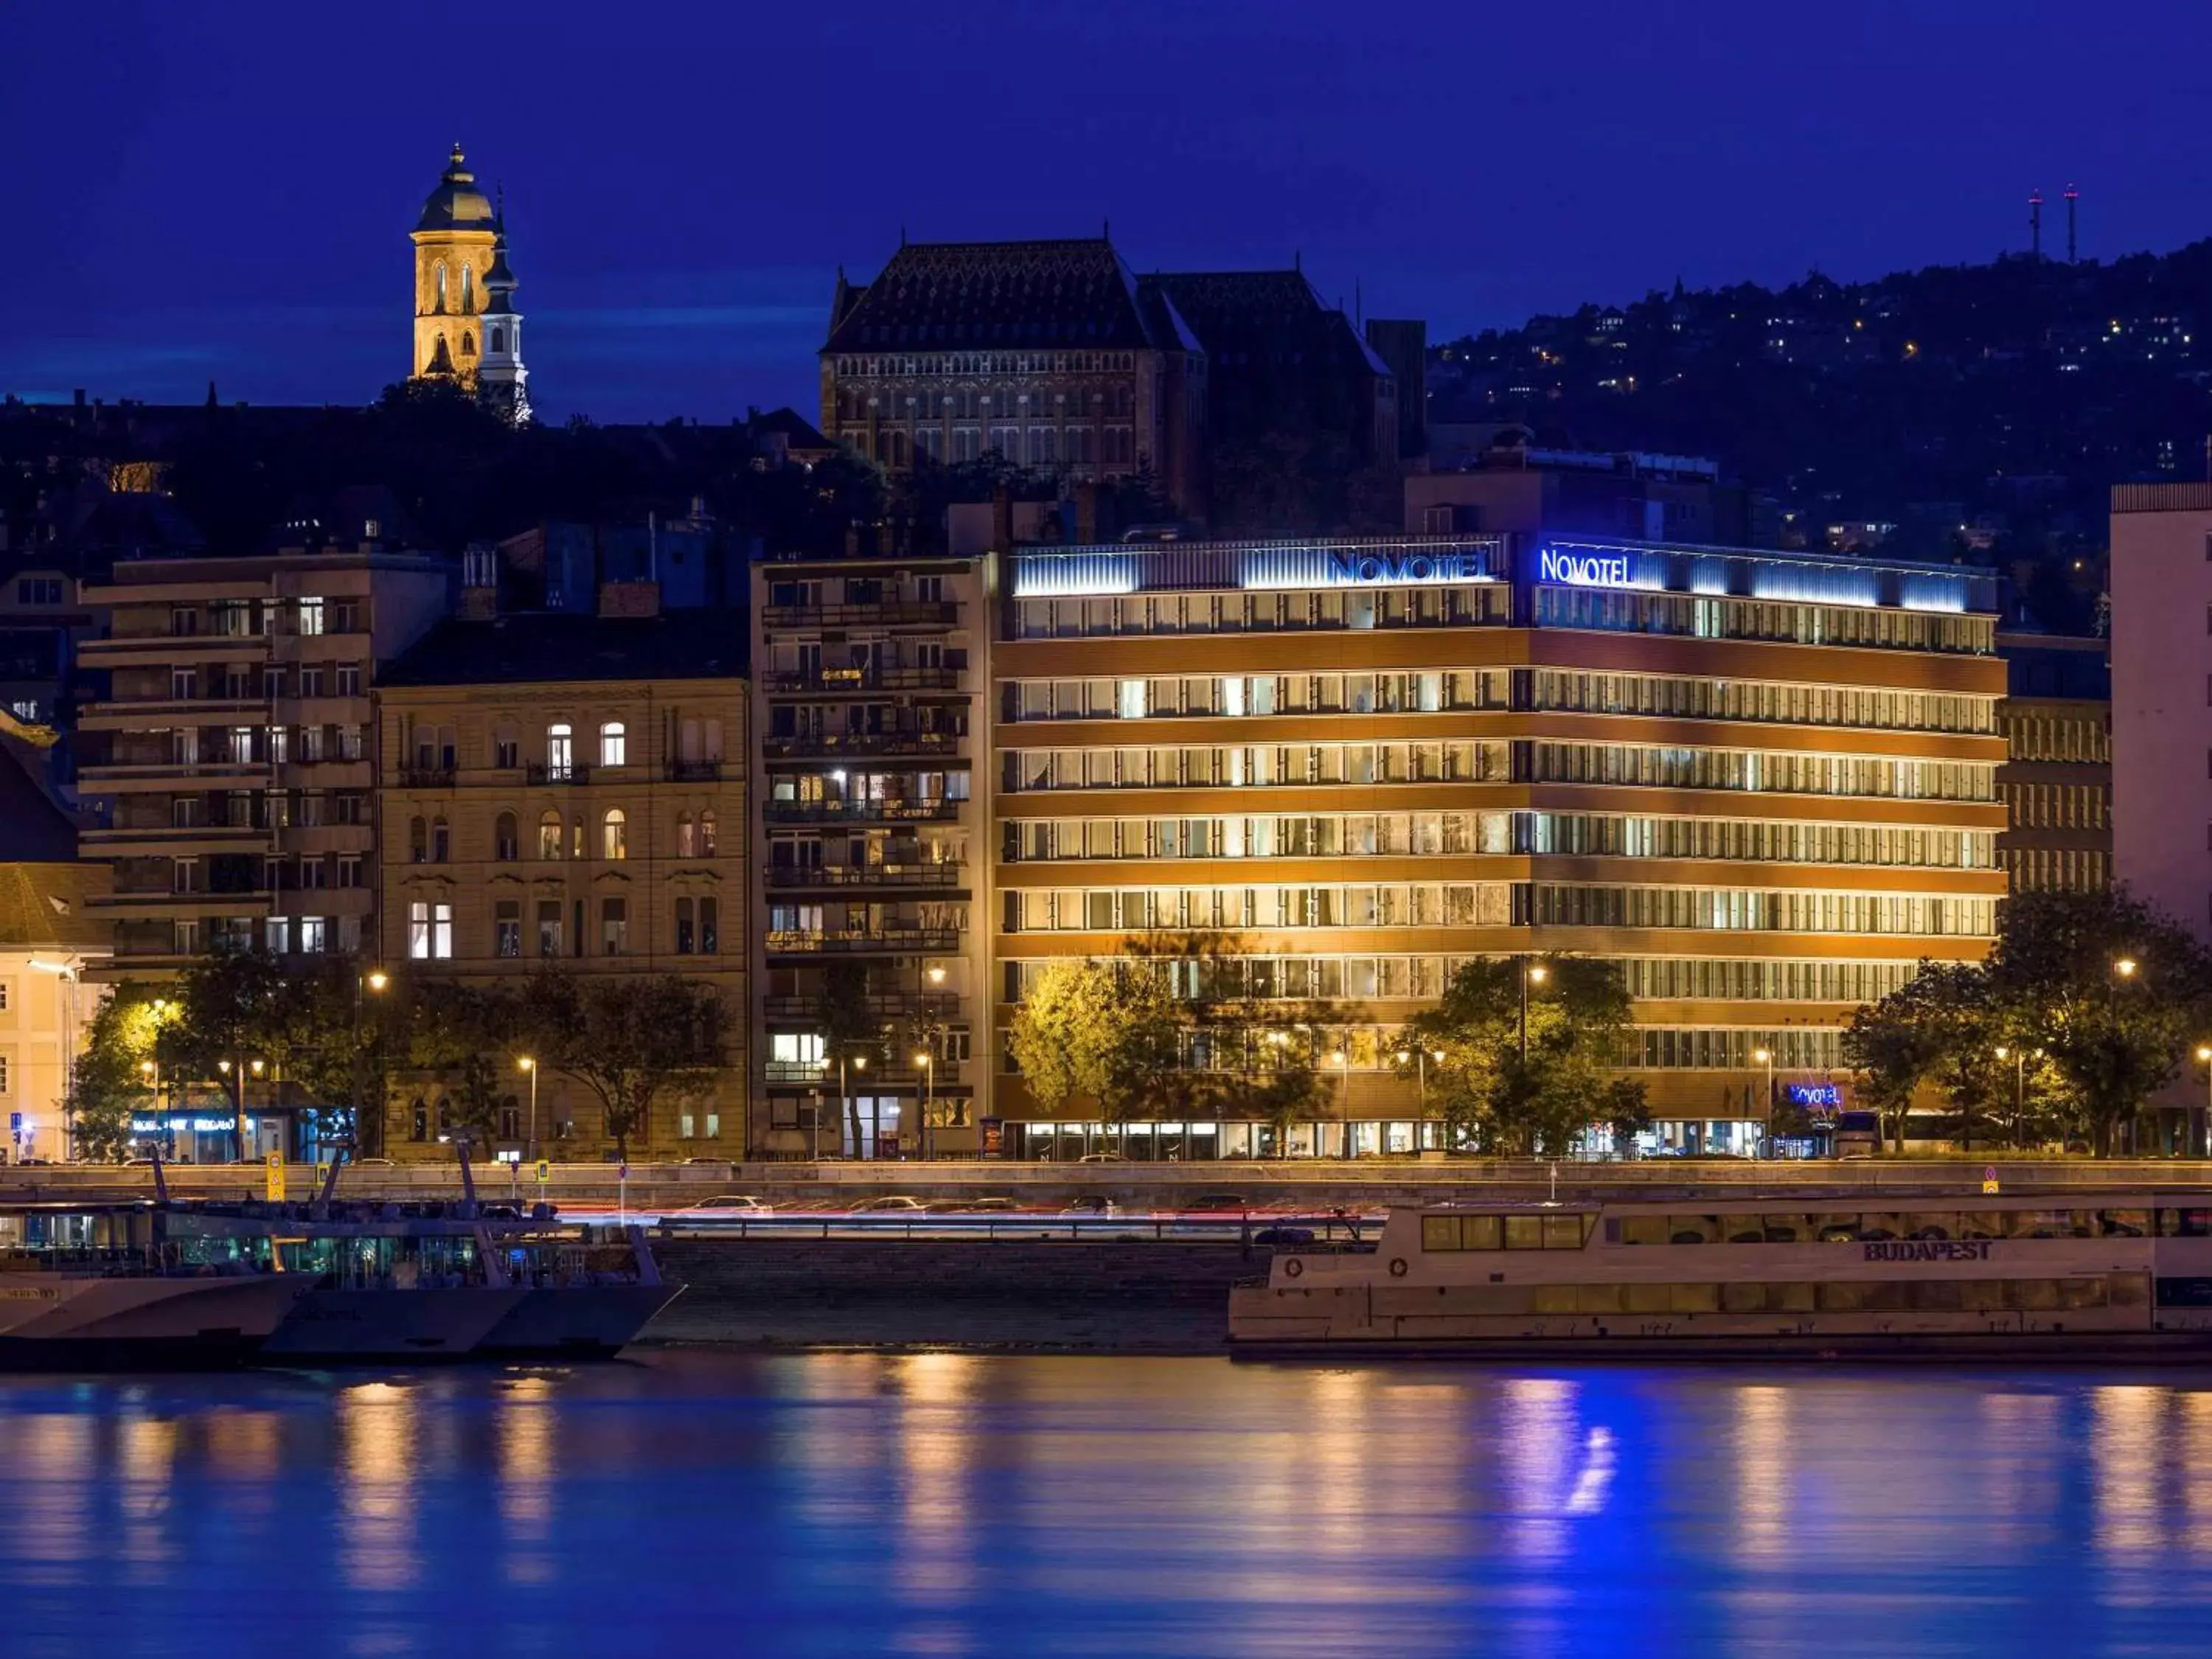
[{"x1": 0, "y1": 1201, "x2": 310, "y2": 1371}]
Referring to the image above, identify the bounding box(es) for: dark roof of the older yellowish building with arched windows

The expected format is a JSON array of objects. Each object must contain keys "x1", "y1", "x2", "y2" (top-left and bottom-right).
[{"x1": 376, "y1": 611, "x2": 745, "y2": 688}]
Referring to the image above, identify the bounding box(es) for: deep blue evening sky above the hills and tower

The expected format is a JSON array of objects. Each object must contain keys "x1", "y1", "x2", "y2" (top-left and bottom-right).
[{"x1": 0, "y1": 0, "x2": 2212, "y2": 420}]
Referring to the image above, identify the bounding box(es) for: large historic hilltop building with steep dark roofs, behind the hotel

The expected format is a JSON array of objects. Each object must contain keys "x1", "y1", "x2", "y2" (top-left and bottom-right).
[{"x1": 821, "y1": 237, "x2": 1398, "y2": 518}]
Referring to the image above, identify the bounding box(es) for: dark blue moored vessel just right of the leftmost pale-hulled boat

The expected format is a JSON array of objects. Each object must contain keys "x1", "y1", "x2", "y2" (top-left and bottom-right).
[{"x1": 168, "y1": 1201, "x2": 684, "y2": 1365}]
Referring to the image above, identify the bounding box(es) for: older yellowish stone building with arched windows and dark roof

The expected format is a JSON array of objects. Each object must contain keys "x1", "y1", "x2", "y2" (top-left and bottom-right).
[{"x1": 376, "y1": 606, "x2": 750, "y2": 1161}]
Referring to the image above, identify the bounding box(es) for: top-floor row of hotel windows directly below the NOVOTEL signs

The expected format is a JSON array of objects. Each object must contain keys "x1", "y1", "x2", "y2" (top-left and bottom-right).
[{"x1": 1013, "y1": 582, "x2": 1997, "y2": 657}]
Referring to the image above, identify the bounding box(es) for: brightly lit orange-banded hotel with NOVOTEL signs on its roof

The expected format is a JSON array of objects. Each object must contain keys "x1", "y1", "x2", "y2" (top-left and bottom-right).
[{"x1": 978, "y1": 535, "x2": 2006, "y2": 1159}]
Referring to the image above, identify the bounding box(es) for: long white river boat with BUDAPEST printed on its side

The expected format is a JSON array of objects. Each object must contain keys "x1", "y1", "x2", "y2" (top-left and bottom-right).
[{"x1": 1230, "y1": 1192, "x2": 2212, "y2": 1360}]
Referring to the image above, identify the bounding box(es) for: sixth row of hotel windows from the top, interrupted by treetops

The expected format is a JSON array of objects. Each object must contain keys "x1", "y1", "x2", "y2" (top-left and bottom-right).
[{"x1": 1000, "y1": 956, "x2": 1918, "y2": 1004}]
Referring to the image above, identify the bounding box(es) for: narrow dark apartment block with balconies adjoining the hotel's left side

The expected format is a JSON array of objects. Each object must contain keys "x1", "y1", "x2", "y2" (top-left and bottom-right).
[{"x1": 750, "y1": 557, "x2": 991, "y2": 1157}]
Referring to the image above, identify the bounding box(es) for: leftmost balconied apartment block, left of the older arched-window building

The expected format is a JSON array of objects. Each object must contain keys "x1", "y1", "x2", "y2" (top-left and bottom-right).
[{"x1": 77, "y1": 540, "x2": 451, "y2": 978}]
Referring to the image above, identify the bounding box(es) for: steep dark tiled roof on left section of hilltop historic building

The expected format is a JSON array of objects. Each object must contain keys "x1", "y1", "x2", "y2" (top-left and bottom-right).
[{"x1": 823, "y1": 237, "x2": 1155, "y2": 352}]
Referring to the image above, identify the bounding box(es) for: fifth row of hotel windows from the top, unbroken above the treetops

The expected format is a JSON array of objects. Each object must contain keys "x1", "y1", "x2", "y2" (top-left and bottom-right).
[{"x1": 1004, "y1": 883, "x2": 1995, "y2": 938}]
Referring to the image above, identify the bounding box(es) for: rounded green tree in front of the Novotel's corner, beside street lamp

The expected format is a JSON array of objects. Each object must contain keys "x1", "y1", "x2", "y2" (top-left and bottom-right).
[{"x1": 1396, "y1": 956, "x2": 1650, "y2": 1157}]
